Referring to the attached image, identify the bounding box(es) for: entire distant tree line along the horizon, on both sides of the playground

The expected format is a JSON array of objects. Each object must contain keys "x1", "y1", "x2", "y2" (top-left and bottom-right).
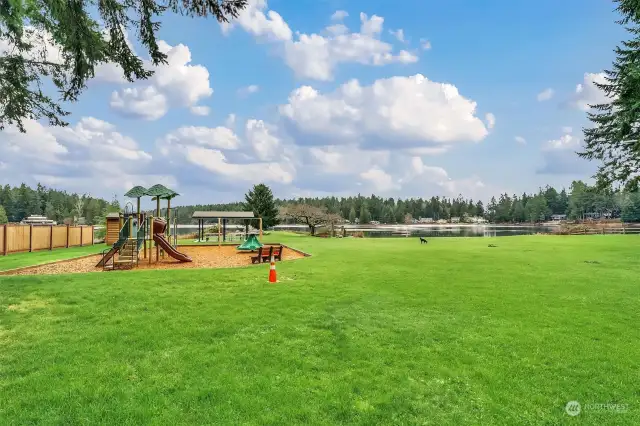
[{"x1": 0, "y1": 180, "x2": 640, "y2": 227}]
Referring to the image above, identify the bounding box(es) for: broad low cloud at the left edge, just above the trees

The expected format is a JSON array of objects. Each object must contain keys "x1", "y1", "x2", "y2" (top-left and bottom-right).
[{"x1": 0, "y1": 117, "x2": 169, "y2": 197}]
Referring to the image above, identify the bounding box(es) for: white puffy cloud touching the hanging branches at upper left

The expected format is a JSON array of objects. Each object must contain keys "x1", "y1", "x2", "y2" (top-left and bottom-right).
[{"x1": 110, "y1": 40, "x2": 213, "y2": 120}]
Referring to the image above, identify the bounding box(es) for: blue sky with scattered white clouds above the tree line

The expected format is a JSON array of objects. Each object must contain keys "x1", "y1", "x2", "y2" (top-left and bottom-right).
[{"x1": 0, "y1": 0, "x2": 625, "y2": 203}]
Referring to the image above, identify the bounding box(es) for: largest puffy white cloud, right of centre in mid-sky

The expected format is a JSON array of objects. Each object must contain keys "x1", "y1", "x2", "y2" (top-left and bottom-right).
[{"x1": 280, "y1": 74, "x2": 495, "y2": 148}]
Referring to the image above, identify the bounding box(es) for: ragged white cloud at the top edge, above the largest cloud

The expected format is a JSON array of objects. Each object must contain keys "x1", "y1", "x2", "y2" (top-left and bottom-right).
[{"x1": 222, "y1": 0, "x2": 418, "y2": 81}]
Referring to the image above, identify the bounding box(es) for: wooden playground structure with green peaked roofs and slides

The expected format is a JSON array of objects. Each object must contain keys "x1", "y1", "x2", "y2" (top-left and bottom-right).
[{"x1": 96, "y1": 184, "x2": 192, "y2": 270}]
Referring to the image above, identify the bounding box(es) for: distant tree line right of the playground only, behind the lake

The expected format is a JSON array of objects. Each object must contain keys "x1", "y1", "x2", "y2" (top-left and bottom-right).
[{"x1": 178, "y1": 180, "x2": 640, "y2": 226}]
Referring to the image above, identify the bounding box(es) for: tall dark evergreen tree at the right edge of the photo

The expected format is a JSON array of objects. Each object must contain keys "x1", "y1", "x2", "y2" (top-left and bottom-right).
[{"x1": 579, "y1": 0, "x2": 640, "y2": 190}]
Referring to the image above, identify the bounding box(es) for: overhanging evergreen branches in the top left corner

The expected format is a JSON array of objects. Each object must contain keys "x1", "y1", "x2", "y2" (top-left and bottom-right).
[{"x1": 0, "y1": 0, "x2": 247, "y2": 132}]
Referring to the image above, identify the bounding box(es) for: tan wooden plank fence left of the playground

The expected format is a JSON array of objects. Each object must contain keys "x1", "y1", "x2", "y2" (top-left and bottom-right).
[{"x1": 0, "y1": 224, "x2": 94, "y2": 256}]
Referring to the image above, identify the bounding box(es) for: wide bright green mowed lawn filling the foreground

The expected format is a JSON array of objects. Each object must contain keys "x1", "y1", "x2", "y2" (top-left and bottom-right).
[{"x1": 0, "y1": 234, "x2": 640, "y2": 425}]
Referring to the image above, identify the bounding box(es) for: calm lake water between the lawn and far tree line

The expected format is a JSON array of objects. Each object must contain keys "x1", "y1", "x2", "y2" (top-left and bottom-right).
[{"x1": 275, "y1": 224, "x2": 554, "y2": 238}]
